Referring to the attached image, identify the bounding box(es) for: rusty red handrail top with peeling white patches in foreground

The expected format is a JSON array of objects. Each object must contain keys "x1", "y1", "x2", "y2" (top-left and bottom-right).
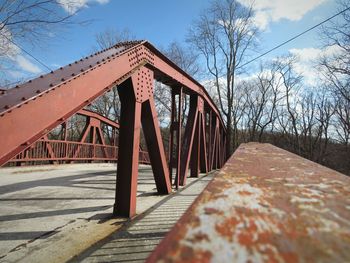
[{"x1": 148, "y1": 143, "x2": 350, "y2": 262}]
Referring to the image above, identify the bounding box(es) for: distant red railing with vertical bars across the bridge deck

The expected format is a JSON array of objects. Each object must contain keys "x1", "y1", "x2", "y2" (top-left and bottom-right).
[{"x1": 8, "y1": 139, "x2": 150, "y2": 165}]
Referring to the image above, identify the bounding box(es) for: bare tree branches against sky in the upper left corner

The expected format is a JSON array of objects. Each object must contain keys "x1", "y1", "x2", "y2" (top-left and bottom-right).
[{"x1": 0, "y1": 0, "x2": 84, "y2": 87}]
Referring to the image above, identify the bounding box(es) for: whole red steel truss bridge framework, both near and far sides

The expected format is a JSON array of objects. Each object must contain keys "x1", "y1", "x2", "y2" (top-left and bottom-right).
[{"x1": 0, "y1": 41, "x2": 226, "y2": 217}]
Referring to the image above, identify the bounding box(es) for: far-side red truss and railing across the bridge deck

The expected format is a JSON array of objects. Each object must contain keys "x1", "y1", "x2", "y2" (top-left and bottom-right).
[{"x1": 8, "y1": 109, "x2": 150, "y2": 165}]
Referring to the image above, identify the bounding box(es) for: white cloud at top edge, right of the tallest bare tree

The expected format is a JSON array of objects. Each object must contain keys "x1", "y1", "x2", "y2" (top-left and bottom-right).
[{"x1": 238, "y1": 0, "x2": 328, "y2": 30}]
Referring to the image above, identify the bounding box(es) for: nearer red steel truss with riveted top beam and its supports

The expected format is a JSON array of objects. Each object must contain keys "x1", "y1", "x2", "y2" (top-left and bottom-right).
[{"x1": 0, "y1": 41, "x2": 225, "y2": 219}]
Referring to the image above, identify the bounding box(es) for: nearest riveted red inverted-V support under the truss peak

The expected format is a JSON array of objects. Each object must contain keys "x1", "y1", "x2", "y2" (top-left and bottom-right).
[{"x1": 113, "y1": 68, "x2": 171, "y2": 217}]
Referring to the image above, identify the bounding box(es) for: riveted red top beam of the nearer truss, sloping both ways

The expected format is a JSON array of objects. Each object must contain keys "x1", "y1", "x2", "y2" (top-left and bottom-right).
[{"x1": 0, "y1": 41, "x2": 223, "y2": 165}]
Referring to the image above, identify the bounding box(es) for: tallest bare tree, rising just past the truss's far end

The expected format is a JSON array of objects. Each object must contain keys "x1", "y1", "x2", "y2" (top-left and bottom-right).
[{"x1": 188, "y1": 0, "x2": 257, "y2": 156}]
